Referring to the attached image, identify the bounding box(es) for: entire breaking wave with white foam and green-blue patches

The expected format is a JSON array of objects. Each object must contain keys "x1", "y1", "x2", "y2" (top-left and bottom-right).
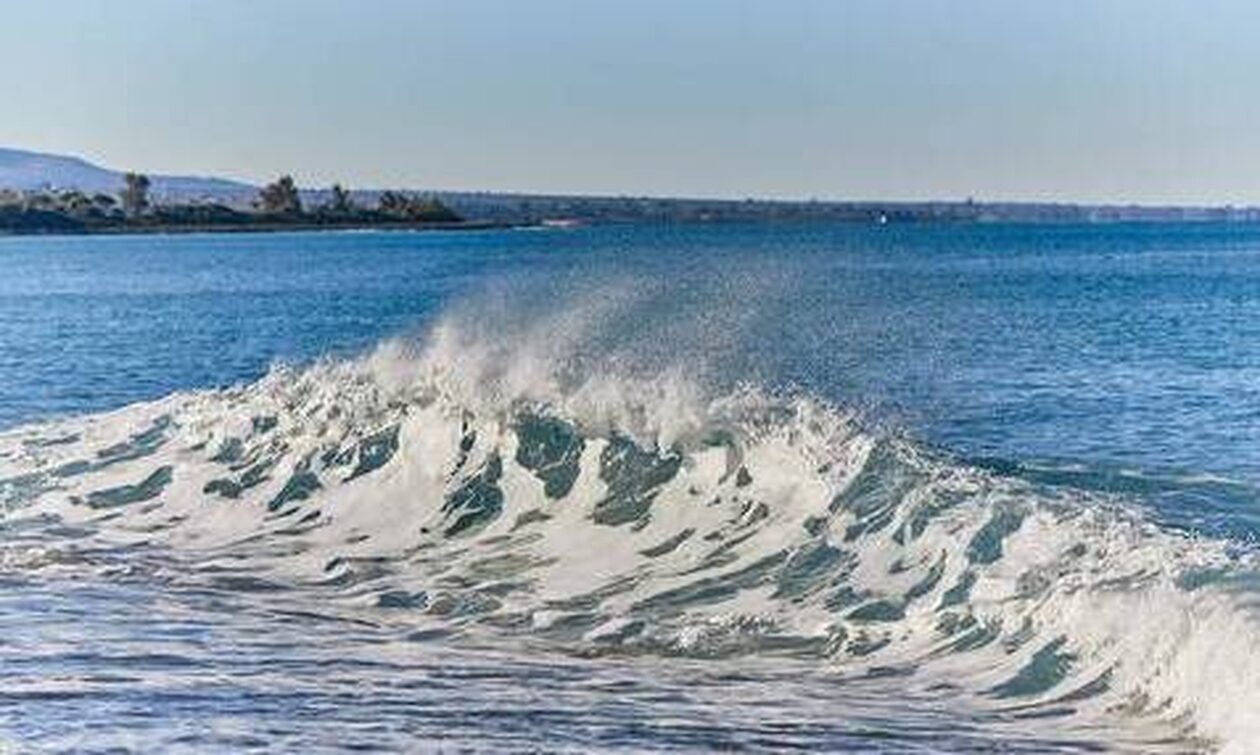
[{"x1": 0, "y1": 316, "x2": 1260, "y2": 751}]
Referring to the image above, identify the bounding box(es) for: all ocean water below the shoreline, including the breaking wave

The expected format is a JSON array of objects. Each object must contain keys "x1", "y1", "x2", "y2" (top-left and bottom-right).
[{"x1": 0, "y1": 224, "x2": 1260, "y2": 752}]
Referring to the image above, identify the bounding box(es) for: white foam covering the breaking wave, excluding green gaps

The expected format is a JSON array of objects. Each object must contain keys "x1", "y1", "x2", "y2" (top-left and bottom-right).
[{"x1": 0, "y1": 321, "x2": 1260, "y2": 752}]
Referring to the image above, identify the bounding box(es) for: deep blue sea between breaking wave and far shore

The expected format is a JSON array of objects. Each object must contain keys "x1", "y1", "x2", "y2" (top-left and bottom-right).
[{"x1": 0, "y1": 224, "x2": 1260, "y2": 483}]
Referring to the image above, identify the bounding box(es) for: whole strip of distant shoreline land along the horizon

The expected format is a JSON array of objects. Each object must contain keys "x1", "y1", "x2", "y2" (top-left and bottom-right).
[{"x1": 0, "y1": 166, "x2": 1260, "y2": 234}]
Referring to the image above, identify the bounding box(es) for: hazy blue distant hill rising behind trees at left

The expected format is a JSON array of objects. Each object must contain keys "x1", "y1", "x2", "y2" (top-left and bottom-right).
[{"x1": 0, "y1": 147, "x2": 256, "y2": 200}]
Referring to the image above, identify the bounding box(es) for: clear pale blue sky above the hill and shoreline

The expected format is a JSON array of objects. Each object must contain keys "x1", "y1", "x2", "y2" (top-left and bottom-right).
[{"x1": 0, "y1": 0, "x2": 1260, "y2": 203}]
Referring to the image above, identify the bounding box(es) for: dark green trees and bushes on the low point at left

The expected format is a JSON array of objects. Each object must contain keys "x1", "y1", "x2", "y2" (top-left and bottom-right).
[{"x1": 0, "y1": 173, "x2": 464, "y2": 233}]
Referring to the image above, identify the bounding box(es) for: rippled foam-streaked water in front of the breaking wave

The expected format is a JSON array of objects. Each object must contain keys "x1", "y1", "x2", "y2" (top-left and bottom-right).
[{"x1": 0, "y1": 581, "x2": 1139, "y2": 752}]
